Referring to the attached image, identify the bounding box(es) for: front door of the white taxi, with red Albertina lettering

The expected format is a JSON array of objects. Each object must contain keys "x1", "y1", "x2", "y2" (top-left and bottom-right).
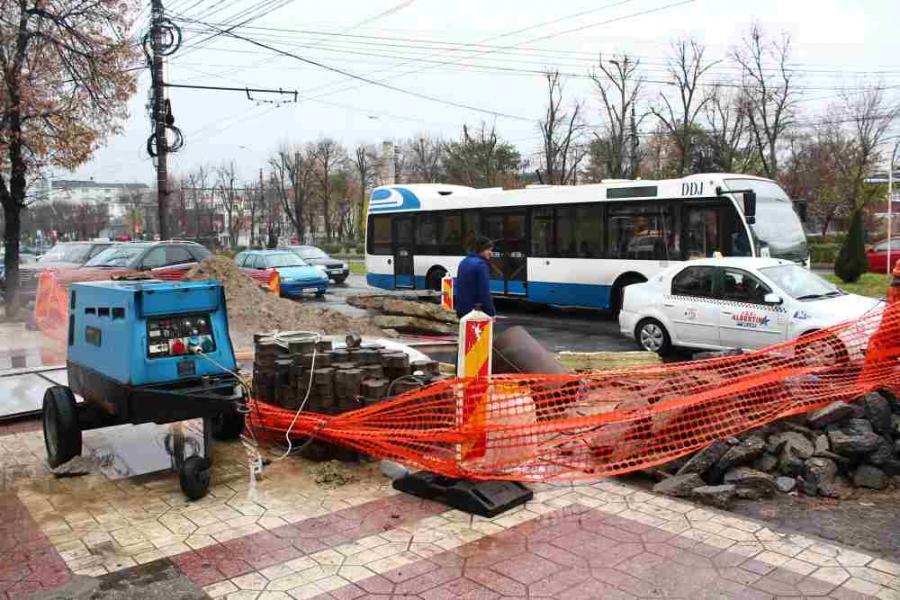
[{"x1": 718, "y1": 267, "x2": 788, "y2": 350}]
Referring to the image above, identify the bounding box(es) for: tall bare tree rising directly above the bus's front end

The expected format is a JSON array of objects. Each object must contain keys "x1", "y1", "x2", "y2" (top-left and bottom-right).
[{"x1": 732, "y1": 23, "x2": 797, "y2": 179}]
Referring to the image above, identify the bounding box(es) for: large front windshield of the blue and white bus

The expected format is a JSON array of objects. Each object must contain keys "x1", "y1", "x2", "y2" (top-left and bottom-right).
[{"x1": 725, "y1": 179, "x2": 809, "y2": 262}]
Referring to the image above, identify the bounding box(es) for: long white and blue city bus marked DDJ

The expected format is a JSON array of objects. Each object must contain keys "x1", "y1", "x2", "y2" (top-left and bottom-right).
[{"x1": 366, "y1": 173, "x2": 809, "y2": 310}]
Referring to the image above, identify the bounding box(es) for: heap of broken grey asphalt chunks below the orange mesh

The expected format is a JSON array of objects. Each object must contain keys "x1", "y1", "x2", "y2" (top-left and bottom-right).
[{"x1": 652, "y1": 390, "x2": 900, "y2": 508}]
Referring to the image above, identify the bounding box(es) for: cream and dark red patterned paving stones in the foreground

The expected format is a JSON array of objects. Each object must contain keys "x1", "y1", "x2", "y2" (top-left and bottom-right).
[{"x1": 0, "y1": 428, "x2": 900, "y2": 600}]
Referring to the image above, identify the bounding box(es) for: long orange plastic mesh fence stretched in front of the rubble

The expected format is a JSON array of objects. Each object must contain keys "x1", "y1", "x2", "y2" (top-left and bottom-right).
[{"x1": 249, "y1": 304, "x2": 900, "y2": 481}]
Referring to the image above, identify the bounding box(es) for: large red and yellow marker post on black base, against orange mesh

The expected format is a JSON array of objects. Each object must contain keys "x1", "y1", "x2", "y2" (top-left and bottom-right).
[{"x1": 456, "y1": 306, "x2": 494, "y2": 461}]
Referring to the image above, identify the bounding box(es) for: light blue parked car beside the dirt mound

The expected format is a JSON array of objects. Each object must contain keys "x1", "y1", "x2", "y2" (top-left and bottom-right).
[{"x1": 234, "y1": 250, "x2": 330, "y2": 297}]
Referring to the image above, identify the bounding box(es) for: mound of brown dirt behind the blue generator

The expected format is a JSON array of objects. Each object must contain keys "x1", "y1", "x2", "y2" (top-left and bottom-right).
[{"x1": 185, "y1": 255, "x2": 383, "y2": 349}]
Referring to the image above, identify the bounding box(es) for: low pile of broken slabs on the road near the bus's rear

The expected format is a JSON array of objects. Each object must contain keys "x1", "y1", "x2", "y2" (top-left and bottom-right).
[{"x1": 347, "y1": 295, "x2": 459, "y2": 335}]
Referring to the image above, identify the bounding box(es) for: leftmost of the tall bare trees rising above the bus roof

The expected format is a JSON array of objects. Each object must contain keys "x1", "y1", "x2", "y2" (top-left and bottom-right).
[{"x1": 536, "y1": 71, "x2": 587, "y2": 185}]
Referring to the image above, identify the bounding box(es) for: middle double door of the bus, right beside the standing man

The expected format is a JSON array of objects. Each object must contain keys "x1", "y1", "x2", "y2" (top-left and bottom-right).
[{"x1": 482, "y1": 212, "x2": 528, "y2": 296}]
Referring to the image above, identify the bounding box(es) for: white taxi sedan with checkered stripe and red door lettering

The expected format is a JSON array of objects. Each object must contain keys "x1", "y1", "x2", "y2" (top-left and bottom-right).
[{"x1": 619, "y1": 258, "x2": 880, "y2": 354}]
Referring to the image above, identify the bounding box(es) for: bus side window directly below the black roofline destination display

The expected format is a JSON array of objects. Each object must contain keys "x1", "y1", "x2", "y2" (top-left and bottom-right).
[{"x1": 609, "y1": 204, "x2": 676, "y2": 260}]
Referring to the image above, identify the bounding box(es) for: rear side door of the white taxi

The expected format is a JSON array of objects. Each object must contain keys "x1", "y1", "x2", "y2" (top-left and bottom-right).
[{"x1": 663, "y1": 266, "x2": 720, "y2": 348}]
